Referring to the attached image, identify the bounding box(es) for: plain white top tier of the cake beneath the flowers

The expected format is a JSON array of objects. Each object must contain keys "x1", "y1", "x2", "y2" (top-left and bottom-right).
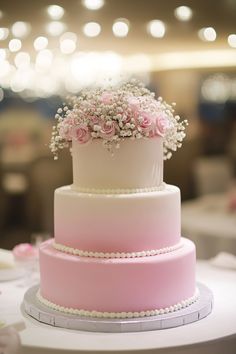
[{"x1": 72, "y1": 137, "x2": 163, "y2": 192}]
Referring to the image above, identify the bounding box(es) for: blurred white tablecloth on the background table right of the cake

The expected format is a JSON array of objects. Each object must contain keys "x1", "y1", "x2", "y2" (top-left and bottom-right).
[{"x1": 181, "y1": 194, "x2": 236, "y2": 259}]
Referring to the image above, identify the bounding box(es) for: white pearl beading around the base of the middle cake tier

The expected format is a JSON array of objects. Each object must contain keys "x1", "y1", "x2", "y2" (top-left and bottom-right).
[{"x1": 53, "y1": 241, "x2": 182, "y2": 258}]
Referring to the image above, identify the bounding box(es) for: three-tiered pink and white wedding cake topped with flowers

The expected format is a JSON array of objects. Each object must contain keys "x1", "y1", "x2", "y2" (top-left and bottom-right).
[{"x1": 38, "y1": 81, "x2": 198, "y2": 318}]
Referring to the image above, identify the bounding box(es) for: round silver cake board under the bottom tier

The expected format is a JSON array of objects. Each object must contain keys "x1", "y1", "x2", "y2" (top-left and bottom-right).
[{"x1": 22, "y1": 283, "x2": 213, "y2": 333}]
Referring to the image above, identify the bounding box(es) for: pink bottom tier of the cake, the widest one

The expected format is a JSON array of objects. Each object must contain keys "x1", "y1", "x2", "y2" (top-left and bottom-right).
[{"x1": 38, "y1": 238, "x2": 197, "y2": 317}]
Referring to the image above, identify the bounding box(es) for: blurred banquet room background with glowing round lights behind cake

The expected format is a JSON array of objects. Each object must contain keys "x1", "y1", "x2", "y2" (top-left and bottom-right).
[{"x1": 0, "y1": 0, "x2": 236, "y2": 258}]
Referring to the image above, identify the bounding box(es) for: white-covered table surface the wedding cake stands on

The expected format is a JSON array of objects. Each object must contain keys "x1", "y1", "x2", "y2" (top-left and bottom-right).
[{"x1": 0, "y1": 261, "x2": 236, "y2": 353}]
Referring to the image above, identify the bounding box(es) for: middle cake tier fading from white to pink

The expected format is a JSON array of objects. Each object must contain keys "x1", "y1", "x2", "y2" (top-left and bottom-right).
[{"x1": 54, "y1": 185, "x2": 181, "y2": 252}]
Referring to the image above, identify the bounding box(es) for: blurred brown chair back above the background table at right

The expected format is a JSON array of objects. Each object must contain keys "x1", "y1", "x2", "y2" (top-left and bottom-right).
[{"x1": 193, "y1": 156, "x2": 233, "y2": 196}]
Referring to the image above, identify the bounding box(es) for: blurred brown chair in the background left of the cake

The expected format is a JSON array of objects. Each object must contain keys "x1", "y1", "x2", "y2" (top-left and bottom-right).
[{"x1": 28, "y1": 152, "x2": 72, "y2": 234}]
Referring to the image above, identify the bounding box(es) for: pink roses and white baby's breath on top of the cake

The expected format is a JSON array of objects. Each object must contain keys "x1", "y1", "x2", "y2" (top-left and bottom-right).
[{"x1": 50, "y1": 79, "x2": 187, "y2": 159}]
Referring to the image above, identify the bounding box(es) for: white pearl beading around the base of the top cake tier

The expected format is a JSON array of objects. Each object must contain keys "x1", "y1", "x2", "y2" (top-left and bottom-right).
[{"x1": 71, "y1": 182, "x2": 166, "y2": 194}]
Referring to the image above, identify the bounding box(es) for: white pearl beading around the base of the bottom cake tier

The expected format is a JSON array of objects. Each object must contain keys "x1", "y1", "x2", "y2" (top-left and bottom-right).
[{"x1": 36, "y1": 289, "x2": 199, "y2": 318}]
